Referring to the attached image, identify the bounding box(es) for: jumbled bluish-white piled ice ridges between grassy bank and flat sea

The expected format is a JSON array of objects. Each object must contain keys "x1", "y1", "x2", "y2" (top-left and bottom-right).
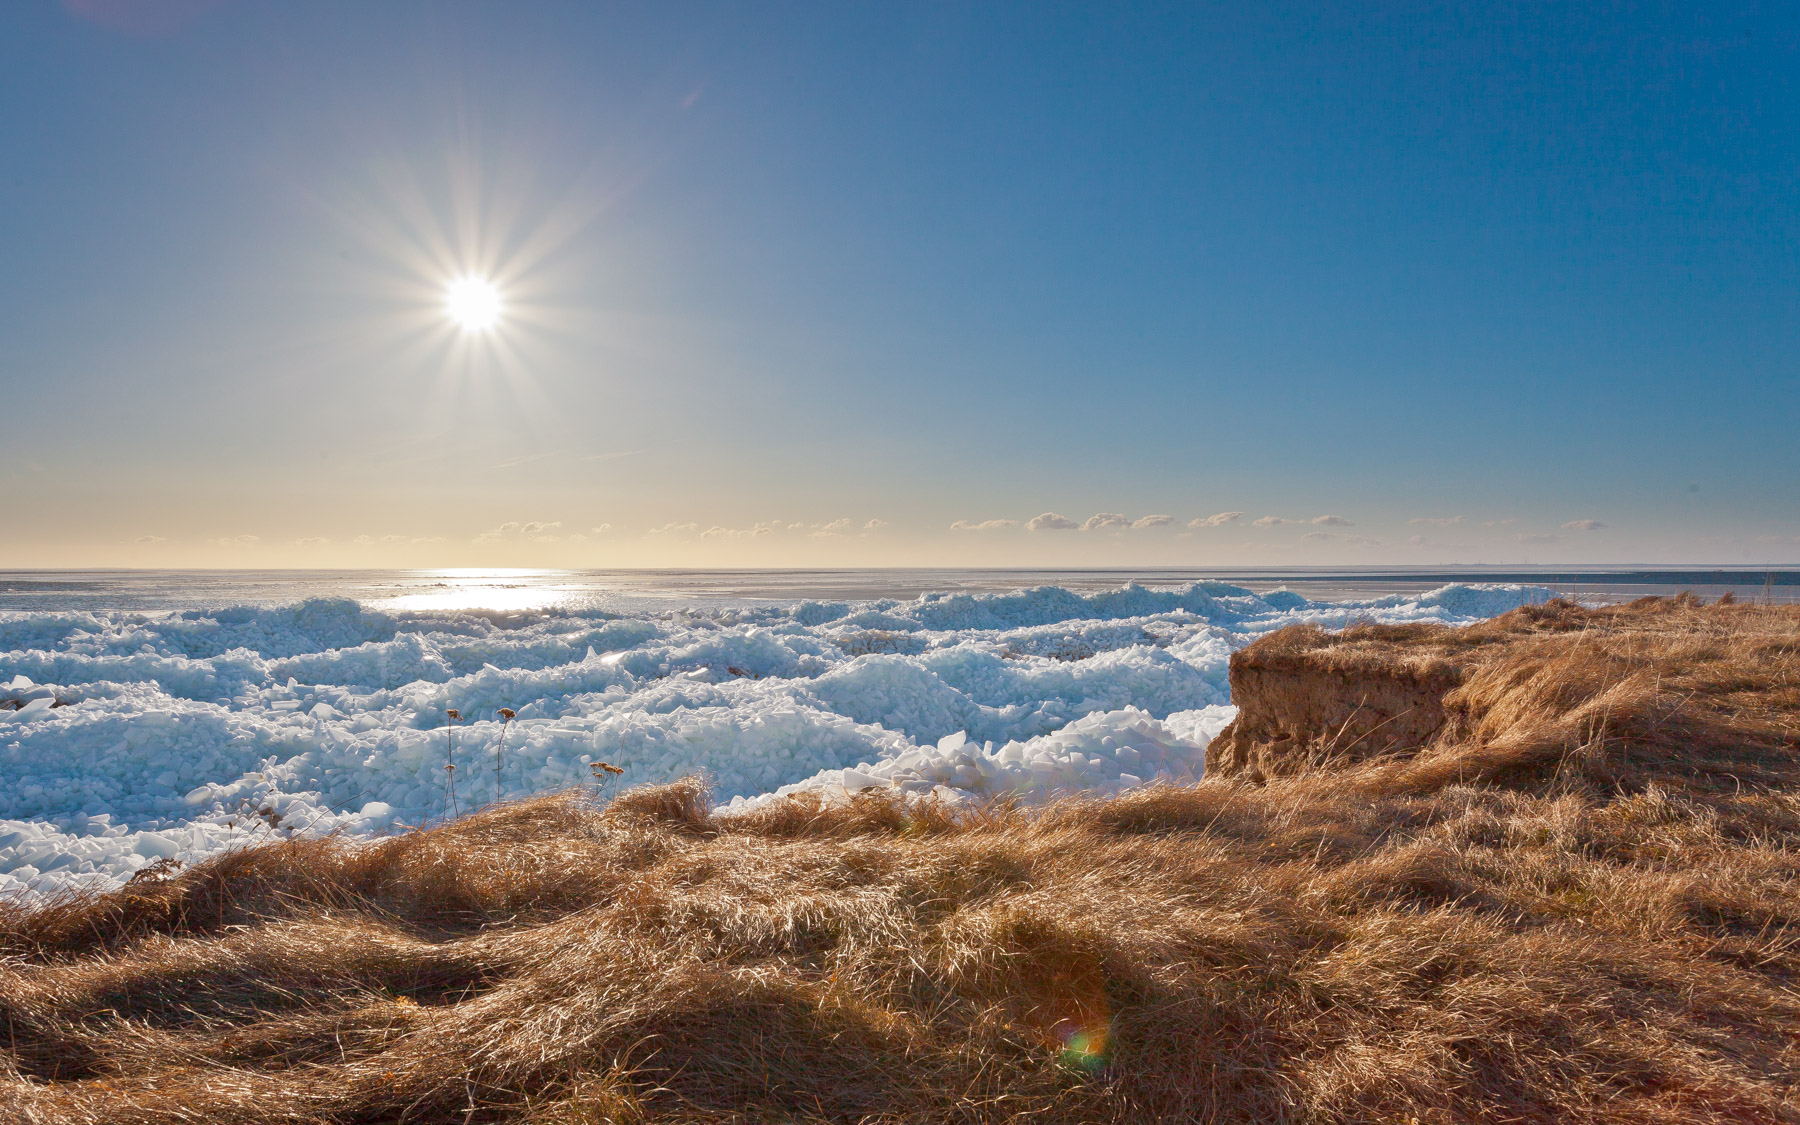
[{"x1": 0, "y1": 583, "x2": 1552, "y2": 895}]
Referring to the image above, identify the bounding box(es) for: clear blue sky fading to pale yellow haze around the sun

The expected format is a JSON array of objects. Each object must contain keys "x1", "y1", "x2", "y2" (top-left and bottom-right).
[{"x1": 0, "y1": 0, "x2": 1800, "y2": 567}]
